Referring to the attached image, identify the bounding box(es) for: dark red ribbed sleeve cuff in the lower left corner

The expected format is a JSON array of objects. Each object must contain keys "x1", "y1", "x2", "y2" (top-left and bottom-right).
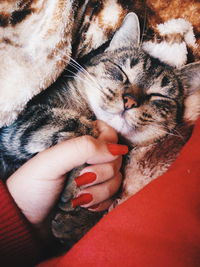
[{"x1": 0, "y1": 181, "x2": 39, "y2": 267}]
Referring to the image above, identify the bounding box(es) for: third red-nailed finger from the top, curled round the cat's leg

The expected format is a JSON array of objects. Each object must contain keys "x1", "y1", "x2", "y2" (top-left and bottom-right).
[{"x1": 72, "y1": 173, "x2": 122, "y2": 208}]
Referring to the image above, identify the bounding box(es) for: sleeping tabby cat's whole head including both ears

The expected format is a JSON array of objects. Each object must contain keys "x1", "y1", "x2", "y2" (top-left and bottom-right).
[{"x1": 77, "y1": 13, "x2": 200, "y2": 145}]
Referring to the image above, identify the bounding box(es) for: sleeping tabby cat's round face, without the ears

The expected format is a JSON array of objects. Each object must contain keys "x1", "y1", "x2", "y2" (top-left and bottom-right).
[{"x1": 83, "y1": 49, "x2": 183, "y2": 144}]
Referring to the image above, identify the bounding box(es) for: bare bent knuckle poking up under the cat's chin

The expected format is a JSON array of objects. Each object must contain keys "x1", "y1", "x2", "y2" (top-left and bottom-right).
[{"x1": 95, "y1": 120, "x2": 118, "y2": 143}]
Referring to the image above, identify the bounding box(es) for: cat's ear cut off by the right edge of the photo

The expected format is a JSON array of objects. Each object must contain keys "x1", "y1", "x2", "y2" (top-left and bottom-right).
[{"x1": 178, "y1": 62, "x2": 200, "y2": 123}]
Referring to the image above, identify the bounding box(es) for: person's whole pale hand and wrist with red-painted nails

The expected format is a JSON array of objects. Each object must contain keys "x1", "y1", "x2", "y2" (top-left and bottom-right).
[{"x1": 7, "y1": 121, "x2": 128, "y2": 226}]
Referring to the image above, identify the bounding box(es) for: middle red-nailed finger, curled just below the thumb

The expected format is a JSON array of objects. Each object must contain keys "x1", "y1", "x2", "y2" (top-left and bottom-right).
[{"x1": 74, "y1": 157, "x2": 122, "y2": 189}]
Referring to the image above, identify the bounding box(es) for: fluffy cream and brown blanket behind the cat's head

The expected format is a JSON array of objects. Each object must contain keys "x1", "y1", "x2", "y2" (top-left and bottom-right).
[{"x1": 0, "y1": 0, "x2": 200, "y2": 127}]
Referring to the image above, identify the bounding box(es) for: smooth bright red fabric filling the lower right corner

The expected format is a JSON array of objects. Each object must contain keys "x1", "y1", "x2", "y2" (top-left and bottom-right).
[{"x1": 39, "y1": 120, "x2": 200, "y2": 267}]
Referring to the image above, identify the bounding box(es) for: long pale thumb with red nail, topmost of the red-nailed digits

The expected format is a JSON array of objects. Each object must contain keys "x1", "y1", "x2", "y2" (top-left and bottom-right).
[{"x1": 36, "y1": 136, "x2": 128, "y2": 177}]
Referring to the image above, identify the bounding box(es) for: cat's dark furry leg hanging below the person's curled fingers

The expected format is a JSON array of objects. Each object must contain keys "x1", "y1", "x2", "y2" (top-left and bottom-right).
[{"x1": 51, "y1": 155, "x2": 105, "y2": 251}]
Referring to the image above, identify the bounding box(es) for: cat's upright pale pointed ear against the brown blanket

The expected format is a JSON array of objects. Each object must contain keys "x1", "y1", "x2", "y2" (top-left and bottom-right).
[{"x1": 108, "y1": 12, "x2": 140, "y2": 50}]
